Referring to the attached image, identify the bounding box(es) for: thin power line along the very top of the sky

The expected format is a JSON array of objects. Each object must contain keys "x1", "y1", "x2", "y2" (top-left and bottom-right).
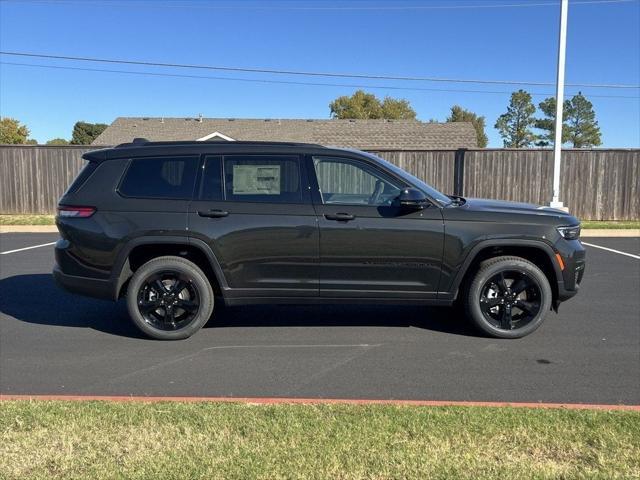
[{"x1": 0, "y1": 0, "x2": 638, "y2": 11}]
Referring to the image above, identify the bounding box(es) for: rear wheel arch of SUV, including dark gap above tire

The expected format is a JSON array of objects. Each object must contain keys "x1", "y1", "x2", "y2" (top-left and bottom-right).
[{"x1": 112, "y1": 236, "x2": 228, "y2": 300}]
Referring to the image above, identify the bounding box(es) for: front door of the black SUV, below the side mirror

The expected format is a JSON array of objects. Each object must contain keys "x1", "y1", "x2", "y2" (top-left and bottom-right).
[{"x1": 308, "y1": 156, "x2": 444, "y2": 299}]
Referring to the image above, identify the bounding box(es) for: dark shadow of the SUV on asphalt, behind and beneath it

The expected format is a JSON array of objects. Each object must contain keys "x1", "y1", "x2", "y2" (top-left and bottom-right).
[{"x1": 0, "y1": 274, "x2": 477, "y2": 338}]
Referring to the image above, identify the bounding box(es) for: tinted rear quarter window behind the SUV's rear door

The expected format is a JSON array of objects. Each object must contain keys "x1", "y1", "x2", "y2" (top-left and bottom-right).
[{"x1": 118, "y1": 156, "x2": 199, "y2": 200}]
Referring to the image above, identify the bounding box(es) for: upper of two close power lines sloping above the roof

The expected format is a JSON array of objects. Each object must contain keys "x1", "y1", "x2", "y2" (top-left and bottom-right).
[{"x1": 0, "y1": 51, "x2": 640, "y2": 89}]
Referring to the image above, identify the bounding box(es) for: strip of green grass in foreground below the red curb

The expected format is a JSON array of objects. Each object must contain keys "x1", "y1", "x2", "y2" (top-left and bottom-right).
[{"x1": 0, "y1": 401, "x2": 640, "y2": 480}]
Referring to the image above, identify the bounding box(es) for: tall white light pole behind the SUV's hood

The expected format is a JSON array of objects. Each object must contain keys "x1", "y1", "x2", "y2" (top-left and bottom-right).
[{"x1": 550, "y1": 0, "x2": 569, "y2": 208}]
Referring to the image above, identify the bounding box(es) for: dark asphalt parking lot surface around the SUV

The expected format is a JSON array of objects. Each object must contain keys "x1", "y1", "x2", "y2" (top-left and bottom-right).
[{"x1": 0, "y1": 233, "x2": 640, "y2": 404}]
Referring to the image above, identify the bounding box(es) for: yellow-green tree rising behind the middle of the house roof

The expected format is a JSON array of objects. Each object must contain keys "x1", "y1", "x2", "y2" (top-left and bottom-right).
[{"x1": 329, "y1": 90, "x2": 416, "y2": 120}]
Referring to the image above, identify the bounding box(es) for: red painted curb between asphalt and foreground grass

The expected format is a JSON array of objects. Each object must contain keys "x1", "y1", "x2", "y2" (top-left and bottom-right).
[{"x1": 0, "y1": 394, "x2": 640, "y2": 411}]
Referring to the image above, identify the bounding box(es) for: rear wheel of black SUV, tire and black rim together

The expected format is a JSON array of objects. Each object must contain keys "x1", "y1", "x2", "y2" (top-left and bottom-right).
[{"x1": 127, "y1": 256, "x2": 214, "y2": 340}]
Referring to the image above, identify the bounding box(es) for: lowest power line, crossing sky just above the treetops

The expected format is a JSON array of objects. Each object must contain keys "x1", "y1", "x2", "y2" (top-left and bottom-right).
[{"x1": 0, "y1": 61, "x2": 640, "y2": 99}]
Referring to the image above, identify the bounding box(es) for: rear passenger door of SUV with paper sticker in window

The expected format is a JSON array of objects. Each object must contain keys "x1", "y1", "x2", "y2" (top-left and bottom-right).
[{"x1": 188, "y1": 154, "x2": 319, "y2": 297}]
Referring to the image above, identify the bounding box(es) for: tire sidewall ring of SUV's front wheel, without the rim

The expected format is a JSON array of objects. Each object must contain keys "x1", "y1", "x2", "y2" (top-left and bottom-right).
[{"x1": 466, "y1": 259, "x2": 552, "y2": 338}]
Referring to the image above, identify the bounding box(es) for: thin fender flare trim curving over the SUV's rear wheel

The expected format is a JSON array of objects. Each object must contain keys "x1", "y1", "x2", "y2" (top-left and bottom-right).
[{"x1": 110, "y1": 235, "x2": 229, "y2": 300}]
